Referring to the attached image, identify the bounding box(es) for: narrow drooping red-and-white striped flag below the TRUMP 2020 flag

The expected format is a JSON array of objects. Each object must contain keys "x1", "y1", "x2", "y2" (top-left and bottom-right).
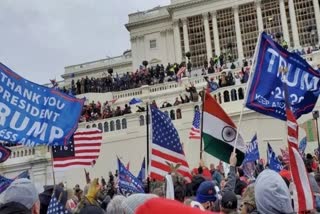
[{"x1": 286, "y1": 109, "x2": 315, "y2": 213}]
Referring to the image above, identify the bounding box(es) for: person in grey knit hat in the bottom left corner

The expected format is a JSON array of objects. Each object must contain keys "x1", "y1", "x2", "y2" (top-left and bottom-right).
[{"x1": 0, "y1": 178, "x2": 40, "y2": 214}]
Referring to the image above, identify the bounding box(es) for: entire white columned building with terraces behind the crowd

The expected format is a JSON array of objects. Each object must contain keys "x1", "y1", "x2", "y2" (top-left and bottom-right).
[{"x1": 0, "y1": 0, "x2": 320, "y2": 190}]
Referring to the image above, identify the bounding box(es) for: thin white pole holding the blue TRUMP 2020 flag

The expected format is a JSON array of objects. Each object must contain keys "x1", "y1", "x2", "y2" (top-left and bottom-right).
[{"x1": 233, "y1": 32, "x2": 262, "y2": 152}]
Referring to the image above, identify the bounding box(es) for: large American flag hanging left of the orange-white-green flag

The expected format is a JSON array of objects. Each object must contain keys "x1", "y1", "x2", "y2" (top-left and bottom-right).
[{"x1": 150, "y1": 107, "x2": 191, "y2": 180}]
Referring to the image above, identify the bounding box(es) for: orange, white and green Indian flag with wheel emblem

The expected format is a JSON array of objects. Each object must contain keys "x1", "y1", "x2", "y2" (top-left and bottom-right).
[{"x1": 202, "y1": 93, "x2": 246, "y2": 166}]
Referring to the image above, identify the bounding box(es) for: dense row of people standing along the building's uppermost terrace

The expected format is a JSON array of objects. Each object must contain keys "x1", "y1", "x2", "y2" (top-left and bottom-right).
[{"x1": 60, "y1": 55, "x2": 246, "y2": 95}]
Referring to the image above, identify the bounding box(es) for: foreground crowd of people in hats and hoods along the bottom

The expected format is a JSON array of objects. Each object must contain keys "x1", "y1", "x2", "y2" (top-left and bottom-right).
[{"x1": 0, "y1": 153, "x2": 320, "y2": 214}]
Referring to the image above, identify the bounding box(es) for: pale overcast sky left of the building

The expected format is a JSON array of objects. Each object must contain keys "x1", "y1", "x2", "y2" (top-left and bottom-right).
[{"x1": 0, "y1": 0, "x2": 170, "y2": 84}]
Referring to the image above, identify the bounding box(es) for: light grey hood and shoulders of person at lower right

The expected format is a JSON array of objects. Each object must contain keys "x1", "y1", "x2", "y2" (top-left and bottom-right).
[{"x1": 254, "y1": 169, "x2": 294, "y2": 214}]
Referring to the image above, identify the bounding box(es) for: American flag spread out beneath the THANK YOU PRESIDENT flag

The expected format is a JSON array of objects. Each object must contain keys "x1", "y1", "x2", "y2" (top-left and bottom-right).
[{"x1": 53, "y1": 128, "x2": 102, "y2": 170}]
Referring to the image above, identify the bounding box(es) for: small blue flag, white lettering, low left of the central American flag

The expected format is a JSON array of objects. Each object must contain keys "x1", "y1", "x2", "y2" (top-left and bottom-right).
[{"x1": 118, "y1": 158, "x2": 144, "y2": 195}]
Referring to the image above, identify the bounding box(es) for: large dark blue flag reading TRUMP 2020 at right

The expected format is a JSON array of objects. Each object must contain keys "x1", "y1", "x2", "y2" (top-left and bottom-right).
[{"x1": 246, "y1": 33, "x2": 320, "y2": 120}]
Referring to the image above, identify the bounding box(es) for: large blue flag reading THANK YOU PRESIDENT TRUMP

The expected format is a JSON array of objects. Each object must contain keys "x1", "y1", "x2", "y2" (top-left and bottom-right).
[{"x1": 0, "y1": 63, "x2": 84, "y2": 146}]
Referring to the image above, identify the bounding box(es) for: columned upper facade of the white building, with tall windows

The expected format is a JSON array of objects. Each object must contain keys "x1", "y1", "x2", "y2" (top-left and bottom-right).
[{"x1": 126, "y1": 0, "x2": 320, "y2": 67}]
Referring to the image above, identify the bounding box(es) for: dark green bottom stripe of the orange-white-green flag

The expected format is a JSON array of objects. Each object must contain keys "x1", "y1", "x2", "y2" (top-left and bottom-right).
[{"x1": 202, "y1": 133, "x2": 245, "y2": 166}]
